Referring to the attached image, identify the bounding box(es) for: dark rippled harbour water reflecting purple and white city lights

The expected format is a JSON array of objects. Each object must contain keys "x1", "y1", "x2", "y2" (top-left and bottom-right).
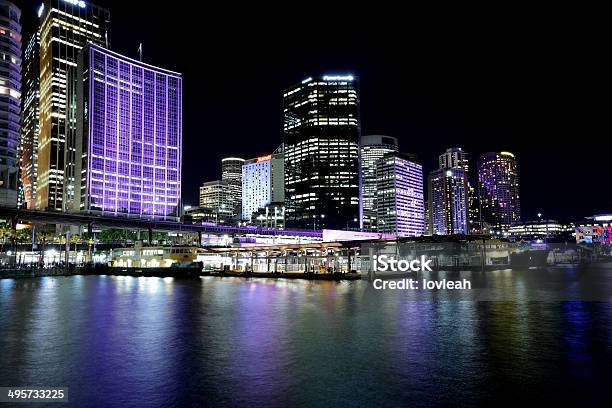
[{"x1": 0, "y1": 268, "x2": 612, "y2": 407}]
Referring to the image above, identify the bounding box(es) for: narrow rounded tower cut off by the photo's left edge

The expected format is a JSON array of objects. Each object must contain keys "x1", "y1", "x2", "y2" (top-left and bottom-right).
[{"x1": 0, "y1": 0, "x2": 21, "y2": 207}]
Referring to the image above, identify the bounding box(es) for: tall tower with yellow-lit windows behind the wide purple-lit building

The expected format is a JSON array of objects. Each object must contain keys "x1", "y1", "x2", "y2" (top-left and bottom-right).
[{"x1": 36, "y1": 0, "x2": 110, "y2": 210}]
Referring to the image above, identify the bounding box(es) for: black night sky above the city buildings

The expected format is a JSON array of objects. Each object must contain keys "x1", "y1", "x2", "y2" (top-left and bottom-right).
[{"x1": 16, "y1": 0, "x2": 612, "y2": 220}]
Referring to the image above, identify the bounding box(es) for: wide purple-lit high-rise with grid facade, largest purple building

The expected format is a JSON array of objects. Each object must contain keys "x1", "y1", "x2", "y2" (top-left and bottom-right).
[{"x1": 69, "y1": 44, "x2": 182, "y2": 220}]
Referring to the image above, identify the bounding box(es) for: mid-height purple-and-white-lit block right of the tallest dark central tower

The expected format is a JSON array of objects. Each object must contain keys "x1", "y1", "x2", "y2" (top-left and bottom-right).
[{"x1": 376, "y1": 152, "x2": 425, "y2": 237}]
